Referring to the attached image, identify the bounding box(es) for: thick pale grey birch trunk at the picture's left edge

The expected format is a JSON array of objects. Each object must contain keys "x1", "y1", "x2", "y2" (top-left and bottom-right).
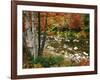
[{"x1": 24, "y1": 12, "x2": 38, "y2": 59}]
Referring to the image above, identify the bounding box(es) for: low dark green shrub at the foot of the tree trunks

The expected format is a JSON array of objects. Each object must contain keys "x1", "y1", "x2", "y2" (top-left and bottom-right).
[{"x1": 30, "y1": 56, "x2": 64, "y2": 68}]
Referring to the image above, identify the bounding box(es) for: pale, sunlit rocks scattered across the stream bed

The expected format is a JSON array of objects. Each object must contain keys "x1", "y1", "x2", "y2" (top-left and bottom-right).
[{"x1": 44, "y1": 36, "x2": 89, "y2": 63}]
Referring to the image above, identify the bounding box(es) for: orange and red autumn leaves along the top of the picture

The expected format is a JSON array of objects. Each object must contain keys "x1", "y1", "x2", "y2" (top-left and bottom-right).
[{"x1": 40, "y1": 12, "x2": 84, "y2": 31}]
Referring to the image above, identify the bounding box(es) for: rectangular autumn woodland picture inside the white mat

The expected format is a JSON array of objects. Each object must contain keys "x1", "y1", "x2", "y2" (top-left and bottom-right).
[{"x1": 22, "y1": 11, "x2": 89, "y2": 68}]
